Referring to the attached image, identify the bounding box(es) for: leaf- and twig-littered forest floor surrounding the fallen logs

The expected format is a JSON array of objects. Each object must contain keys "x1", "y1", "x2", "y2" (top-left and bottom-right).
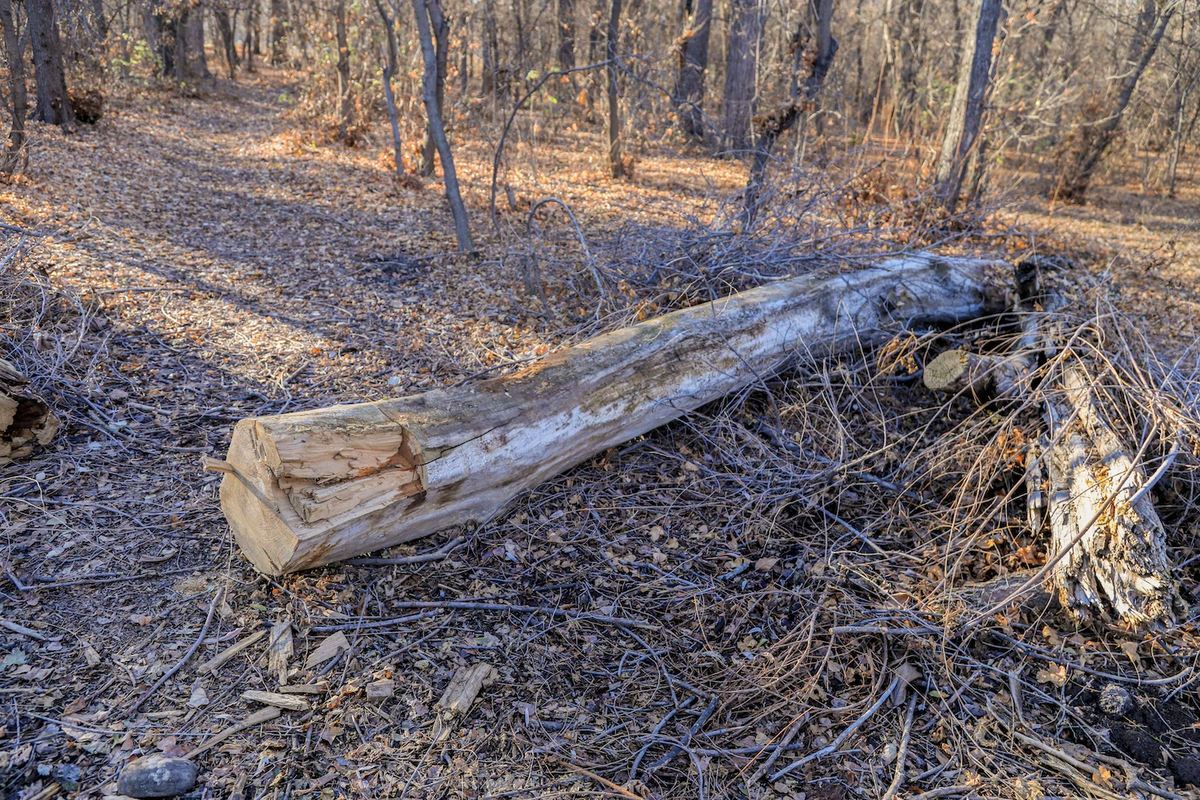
[{"x1": 0, "y1": 72, "x2": 1200, "y2": 800}]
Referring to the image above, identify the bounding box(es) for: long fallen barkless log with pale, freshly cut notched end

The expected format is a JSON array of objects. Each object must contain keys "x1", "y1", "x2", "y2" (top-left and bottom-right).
[{"x1": 210, "y1": 254, "x2": 1006, "y2": 575}]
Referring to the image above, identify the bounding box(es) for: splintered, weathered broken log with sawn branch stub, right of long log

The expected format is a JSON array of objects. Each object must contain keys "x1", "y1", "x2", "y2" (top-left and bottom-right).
[{"x1": 924, "y1": 266, "x2": 1183, "y2": 630}]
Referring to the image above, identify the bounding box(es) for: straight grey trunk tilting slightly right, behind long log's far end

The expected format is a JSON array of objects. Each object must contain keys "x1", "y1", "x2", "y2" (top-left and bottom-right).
[{"x1": 934, "y1": 0, "x2": 1002, "y2": 213}]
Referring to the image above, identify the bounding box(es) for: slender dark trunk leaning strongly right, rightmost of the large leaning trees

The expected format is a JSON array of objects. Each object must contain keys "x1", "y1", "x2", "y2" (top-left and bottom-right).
[{"x1": 1055, "y1": 0, "x2": 1178, "y2": 203}]
